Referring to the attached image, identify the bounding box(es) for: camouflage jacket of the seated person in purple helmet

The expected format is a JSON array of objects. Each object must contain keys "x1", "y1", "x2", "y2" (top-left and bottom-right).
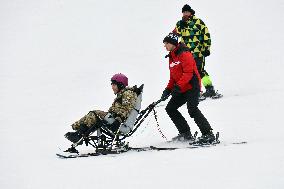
[{"x1": 108, "y1": 87, "x2": 137, "y2": 122}]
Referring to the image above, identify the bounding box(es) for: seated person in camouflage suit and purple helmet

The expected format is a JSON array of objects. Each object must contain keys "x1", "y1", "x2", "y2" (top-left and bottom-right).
[{"x1": 65, "y1": 73, "x2": 137, "y2": 143}]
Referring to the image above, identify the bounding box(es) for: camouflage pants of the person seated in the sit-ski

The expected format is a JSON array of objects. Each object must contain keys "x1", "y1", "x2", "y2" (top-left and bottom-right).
[{"x1": 71, "y1": 110, "x2": 107, "y2": 130}]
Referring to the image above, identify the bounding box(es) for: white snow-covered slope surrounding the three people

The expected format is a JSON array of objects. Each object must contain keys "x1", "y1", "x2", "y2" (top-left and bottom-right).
[{"x1": 0, "y1": 0, "x2": 284, "y2": 189}]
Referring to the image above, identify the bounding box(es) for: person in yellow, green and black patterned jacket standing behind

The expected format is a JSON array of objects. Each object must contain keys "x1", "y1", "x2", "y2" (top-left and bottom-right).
[{"x1": 173, "y1": 4, "x2": 222, "y2": 100}]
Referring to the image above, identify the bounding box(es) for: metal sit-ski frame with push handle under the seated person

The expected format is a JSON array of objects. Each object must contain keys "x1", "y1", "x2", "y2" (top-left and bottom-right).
[{"x1": 66, "y1": 85, "x2": 163, "y2": 154}]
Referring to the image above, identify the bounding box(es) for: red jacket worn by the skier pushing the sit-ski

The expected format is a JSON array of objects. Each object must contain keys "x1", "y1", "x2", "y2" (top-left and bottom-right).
[{"x1": 167, "y1": 43, "x2": 201, "y2": 93}]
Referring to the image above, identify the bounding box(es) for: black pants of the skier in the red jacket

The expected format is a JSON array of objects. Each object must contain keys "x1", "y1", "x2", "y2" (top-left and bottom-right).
[{"x1": 166, "y1": 89, "x2": 212, "y2": 135}]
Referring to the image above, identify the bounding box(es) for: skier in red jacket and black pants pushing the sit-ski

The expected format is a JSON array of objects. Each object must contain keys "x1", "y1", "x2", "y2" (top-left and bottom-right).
[{"x1": 161, "y1": 33, "x2": 215, "y2": 143}]
